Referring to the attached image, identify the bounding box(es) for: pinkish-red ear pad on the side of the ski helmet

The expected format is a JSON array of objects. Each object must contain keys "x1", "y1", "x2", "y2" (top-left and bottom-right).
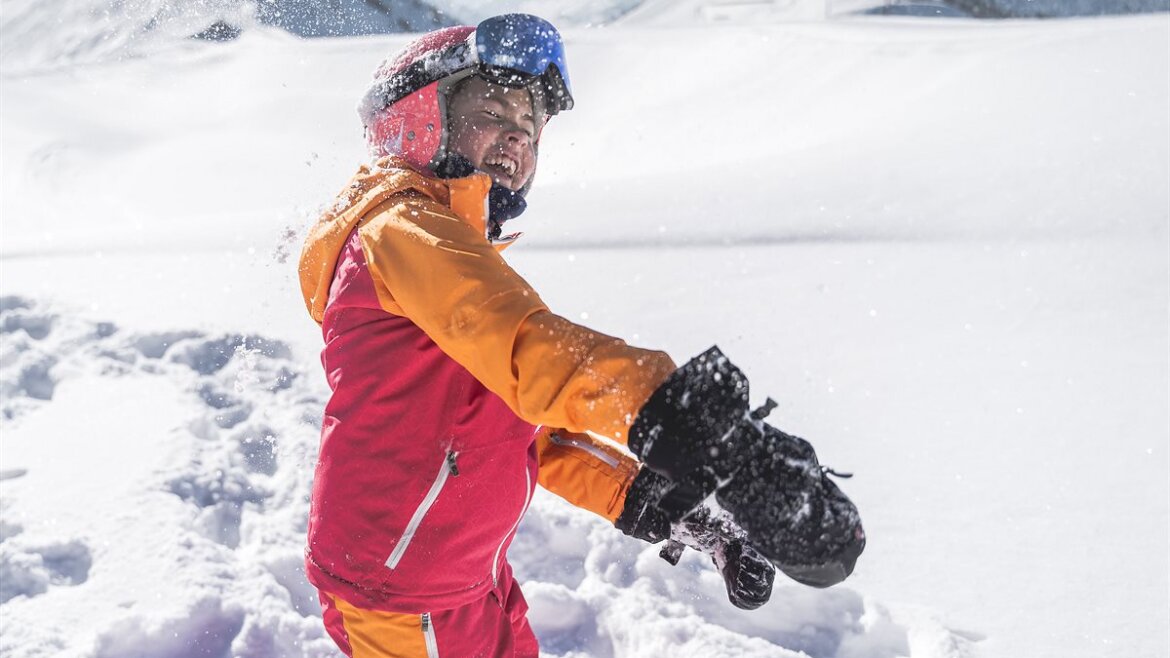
[{"x1": 365, "y1": 81, "x2": 446, "y2": 169}]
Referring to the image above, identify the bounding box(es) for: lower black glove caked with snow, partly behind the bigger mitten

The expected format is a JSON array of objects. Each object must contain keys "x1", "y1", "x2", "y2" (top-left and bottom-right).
[{"x1": 614, "y1": 468, "x2": 776, "y2": 610}]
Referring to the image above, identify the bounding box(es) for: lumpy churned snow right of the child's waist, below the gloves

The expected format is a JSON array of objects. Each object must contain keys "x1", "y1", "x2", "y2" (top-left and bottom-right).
[{"x1": 509, "y1": 492, "x2": 977, "y2": 658}]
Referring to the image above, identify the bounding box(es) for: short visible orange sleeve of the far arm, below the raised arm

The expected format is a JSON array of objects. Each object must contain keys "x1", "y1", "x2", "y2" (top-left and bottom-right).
[{"x1": 536, "y1": 427, "x2": 640, "y2": 522}]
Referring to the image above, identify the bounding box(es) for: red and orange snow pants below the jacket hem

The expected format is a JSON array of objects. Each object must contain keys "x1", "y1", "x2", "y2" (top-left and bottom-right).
[{"x1": 321, "y1": 571, "x2": 539, "y2": 658}]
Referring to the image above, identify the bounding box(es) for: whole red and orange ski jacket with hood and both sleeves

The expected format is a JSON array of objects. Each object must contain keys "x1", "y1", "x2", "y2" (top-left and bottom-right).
[{"x1": 300, "y1": 158, "x2": 674, "y2": 611}]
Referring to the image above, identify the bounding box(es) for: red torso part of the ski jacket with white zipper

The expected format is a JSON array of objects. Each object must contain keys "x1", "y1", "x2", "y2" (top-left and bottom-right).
[{"x1": 307, "y1": 233, "x2": 537, "y2": 612}]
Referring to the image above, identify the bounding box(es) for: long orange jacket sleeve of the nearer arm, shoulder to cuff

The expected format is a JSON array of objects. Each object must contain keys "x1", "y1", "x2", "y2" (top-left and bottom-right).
[{"x1": 359, "y1": 194, "x2": 675, "y2": 444}]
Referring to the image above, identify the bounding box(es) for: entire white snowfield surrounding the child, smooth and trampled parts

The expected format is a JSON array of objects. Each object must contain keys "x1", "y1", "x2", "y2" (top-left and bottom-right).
[{"x1": 0, "y1": 5, "x2": 1170, "y2": 658}]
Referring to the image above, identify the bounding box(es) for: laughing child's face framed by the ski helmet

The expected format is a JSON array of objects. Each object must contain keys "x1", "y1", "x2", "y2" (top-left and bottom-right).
[{"x1": 448, "y1": 77, "x2": 541, "y2": 191}]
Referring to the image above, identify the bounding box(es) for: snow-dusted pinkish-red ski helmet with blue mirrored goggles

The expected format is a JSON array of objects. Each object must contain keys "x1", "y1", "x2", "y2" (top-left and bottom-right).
[{"x1": 358, "y1": 14, "x2": 573, "y2": 170}]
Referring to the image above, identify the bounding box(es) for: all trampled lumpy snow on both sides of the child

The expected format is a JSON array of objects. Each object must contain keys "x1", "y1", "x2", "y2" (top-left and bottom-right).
[{"x1": 0, "y1": 296, "x2": 975, "y2": 658}]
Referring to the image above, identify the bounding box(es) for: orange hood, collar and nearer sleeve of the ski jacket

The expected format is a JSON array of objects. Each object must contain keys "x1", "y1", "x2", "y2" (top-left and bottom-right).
[{"x1": 300, "y1": 157, "x2": 675, "y2": 444}]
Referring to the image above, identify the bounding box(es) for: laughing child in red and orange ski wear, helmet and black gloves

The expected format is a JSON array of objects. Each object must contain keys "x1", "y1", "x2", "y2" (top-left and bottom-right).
[{"x1": 300, "y1": 14, "x2": 863, "y2": 657}]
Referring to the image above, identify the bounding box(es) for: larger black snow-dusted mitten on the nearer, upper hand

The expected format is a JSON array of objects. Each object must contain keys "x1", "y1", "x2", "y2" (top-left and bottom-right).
[{"x1": 629, "y1": 348, "x2": 866, "y2": 587}]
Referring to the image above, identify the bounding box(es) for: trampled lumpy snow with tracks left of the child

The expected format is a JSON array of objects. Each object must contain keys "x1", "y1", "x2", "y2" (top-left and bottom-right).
[{"x1": 0, "y1": 297, "x2": 335, "y2": 658}]
